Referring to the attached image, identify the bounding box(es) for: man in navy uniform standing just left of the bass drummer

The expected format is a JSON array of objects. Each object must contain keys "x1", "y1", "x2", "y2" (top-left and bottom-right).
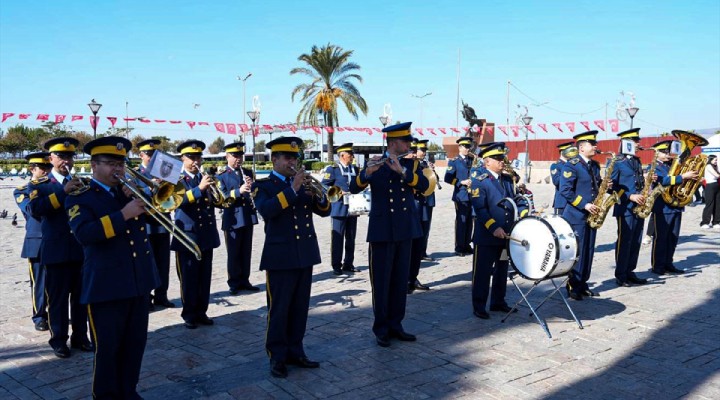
[{"x1": 444, "y1": 137, "x2": 473, "y2": 256}]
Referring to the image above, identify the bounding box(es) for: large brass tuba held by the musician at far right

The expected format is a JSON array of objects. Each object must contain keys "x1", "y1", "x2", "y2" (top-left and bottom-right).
[{"x1": 662, "y1": 130, "x2": 708, "y2": 207}]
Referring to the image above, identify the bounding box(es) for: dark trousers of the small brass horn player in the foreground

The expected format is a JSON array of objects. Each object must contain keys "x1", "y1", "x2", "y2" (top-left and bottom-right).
[{"x1": 265, "y1": 266, "x2": 313, "y2": 361}]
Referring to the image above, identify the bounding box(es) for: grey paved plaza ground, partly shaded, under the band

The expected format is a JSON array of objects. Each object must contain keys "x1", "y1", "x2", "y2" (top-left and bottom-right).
[{"x1": 0, "y1": 173, "x2": 720, "y2": 400}]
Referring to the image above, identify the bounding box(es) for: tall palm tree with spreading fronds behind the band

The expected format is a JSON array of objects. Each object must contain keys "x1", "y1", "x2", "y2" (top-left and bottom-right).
[{"x1": 290, "y1": 43, "x2": 367, "y2": 160}]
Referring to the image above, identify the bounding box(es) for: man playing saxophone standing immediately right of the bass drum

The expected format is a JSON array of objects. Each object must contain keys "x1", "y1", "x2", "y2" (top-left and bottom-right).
[{"x1": 560, "y1": 131, "x2": 602, "y2": 300}]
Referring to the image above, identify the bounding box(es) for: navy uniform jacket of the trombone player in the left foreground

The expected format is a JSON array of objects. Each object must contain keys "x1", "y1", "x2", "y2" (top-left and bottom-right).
[{"x1": 65, "y1": 181, "x2": 160, "y2": 304}]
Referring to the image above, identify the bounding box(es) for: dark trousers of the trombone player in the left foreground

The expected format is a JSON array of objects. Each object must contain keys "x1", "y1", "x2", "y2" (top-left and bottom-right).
[{"x1": 87, "y1": 295, "x2": 148, "y2": 399}]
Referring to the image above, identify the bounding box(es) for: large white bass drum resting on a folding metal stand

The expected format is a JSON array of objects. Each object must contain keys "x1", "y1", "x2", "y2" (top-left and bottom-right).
[{"x1": 508, "y1": 215, "x2": 578, "y2": 281}]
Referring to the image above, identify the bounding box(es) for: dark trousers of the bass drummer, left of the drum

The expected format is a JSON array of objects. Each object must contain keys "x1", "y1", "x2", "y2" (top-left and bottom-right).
[{"x1": 472, "y1": 245, "x2": 508, "y2": 312}]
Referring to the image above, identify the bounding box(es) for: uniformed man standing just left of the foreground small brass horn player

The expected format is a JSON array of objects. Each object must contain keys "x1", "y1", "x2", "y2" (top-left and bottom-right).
[{"x1": 217, "y1": 142, "x2": 260, "y2": 295}]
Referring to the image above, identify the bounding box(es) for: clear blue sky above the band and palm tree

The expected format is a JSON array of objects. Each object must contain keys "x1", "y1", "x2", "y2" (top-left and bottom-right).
[{"x1": 0, "y1": 0, "x2": 720, "y2": 142}]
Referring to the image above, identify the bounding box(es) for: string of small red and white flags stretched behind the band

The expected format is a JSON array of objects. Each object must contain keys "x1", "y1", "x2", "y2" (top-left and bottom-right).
[{"x1": 0, "y1": 112, "x2": 620, "y2": 137}]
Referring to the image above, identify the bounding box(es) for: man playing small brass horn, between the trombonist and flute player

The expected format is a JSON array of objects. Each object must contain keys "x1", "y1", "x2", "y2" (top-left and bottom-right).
[{"x1": 253, "y1": 137, "x2": 330, "y2": 378}]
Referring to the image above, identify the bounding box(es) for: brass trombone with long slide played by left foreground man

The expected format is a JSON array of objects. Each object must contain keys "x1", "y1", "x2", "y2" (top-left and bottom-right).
[{"x1": 114, "y1": 169, "x2": 202, "y2": 261}]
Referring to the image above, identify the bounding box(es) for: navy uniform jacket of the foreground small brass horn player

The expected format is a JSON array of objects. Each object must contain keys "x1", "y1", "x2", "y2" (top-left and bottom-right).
[{"x1": 253, "y1": 174, "x2": 330, "y2": 271}]
